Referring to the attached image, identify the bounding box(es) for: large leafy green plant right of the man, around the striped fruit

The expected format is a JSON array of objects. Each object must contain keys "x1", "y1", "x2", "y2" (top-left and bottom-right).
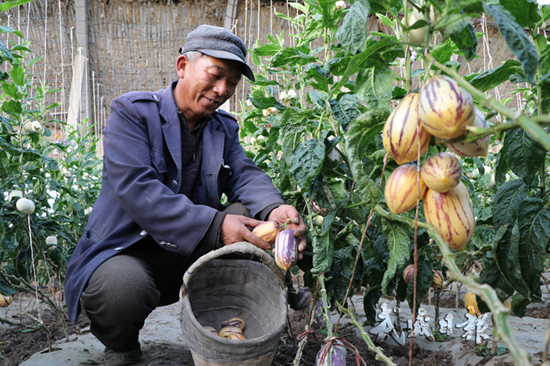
[{"x1": 241, "y1": 0, "x2": 550, "y2": 365}]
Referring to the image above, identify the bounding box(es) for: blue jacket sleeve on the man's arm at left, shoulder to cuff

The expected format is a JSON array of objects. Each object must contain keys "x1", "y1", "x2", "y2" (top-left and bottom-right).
[{"x1": 104, "y1": 96, "x2": 218, "y2": 255}]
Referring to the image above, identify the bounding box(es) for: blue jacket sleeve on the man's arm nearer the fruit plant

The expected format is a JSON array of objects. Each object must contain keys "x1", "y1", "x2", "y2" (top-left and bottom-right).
[{"x1": 225, "y1": 126, "x2": 285, "y2": 219}]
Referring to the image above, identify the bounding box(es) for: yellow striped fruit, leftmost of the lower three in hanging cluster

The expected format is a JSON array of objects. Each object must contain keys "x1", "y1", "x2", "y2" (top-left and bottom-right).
[{"x1": 384, "y1": 164, "x2": 426, "y2": 215}]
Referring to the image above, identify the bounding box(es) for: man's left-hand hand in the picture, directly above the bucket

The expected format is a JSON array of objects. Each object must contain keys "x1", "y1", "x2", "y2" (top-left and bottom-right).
[{"x1": 220, "y1": 214, "x2": 271, "y2": 250}]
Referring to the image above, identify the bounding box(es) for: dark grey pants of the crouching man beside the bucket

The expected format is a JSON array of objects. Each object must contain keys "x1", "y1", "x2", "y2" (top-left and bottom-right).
[{"x1": 81, "y1": 203, "x2": 250, "y2": 352}]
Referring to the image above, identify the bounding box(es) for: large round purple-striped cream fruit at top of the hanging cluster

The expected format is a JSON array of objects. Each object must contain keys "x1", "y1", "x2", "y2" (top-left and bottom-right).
[{"x1": 418, "y1": 75, "x2": 475, "y2": 139}]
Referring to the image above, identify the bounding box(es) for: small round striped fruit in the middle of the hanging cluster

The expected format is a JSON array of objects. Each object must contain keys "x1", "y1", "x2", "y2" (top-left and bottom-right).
[{"x1": 420, "y1": 153, "x2": 462, "y2": 192}]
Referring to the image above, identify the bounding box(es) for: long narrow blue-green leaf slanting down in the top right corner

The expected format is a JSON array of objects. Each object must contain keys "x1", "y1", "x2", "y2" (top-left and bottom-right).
[{"x1": 483, "y1": 4, "x2": 539, "y2": 85}]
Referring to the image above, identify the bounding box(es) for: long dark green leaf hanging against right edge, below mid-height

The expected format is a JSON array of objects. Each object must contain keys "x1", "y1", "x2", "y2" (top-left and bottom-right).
[{"x1": 518, "y1": 197, "x2": 550, "y2": 301}]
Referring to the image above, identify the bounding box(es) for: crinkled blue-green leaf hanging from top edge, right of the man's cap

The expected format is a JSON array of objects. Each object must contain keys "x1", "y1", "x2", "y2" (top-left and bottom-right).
[{"x1": 336, "y1": 0, "x2": 370, "y2": 54}]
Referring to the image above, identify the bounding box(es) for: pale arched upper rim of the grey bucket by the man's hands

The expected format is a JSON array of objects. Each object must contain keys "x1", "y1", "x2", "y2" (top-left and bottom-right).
[{"x1": 181, "y1": 241, "x2": 285, "y2": 298}]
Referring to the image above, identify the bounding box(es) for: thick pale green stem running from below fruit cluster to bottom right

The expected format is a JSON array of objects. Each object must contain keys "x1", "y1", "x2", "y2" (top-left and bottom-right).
[{"x1": 374, "y1": 205, "x2": 531, "y2": 366}]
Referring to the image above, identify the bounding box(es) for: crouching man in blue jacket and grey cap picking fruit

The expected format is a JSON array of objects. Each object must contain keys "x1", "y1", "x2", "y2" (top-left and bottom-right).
[{"x1": 65, "y1": 25, "x2": 306, "y2": 364}]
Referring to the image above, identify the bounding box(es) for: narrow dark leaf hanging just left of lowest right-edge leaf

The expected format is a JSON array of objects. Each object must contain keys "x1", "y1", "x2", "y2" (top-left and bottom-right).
[{"x1": 493, "y1": 221, "x2": 530, "y2": 297}]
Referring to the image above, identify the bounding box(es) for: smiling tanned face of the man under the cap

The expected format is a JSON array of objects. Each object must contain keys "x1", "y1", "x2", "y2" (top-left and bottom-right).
[{"x1": 175, "y1": 56, "x2": 242, "y2": 122}]
